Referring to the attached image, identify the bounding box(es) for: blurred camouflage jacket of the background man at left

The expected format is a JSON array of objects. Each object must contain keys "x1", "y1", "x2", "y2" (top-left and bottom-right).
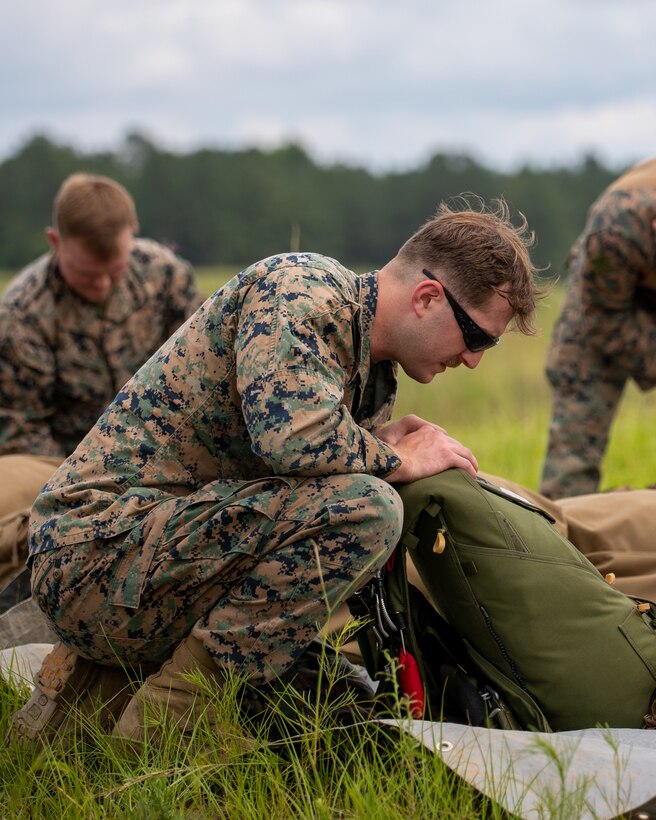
[{"x1": 0, "y1": 239, "x2": 202, "y2": 457}]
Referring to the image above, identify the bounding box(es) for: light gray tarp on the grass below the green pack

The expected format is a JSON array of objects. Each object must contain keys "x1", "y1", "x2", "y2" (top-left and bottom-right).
[{"x1": 384, "y1": 720, "x2": 656, "y2": 820}]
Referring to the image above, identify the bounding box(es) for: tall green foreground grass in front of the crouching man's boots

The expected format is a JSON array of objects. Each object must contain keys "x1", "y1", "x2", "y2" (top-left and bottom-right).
[{"x1": 0, "y1": 640, "x2": 507, "y2": 820}]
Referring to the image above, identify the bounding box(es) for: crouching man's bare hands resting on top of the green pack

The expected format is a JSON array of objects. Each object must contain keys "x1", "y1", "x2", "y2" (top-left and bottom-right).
[{"x1": 375, "y1": 416, "x2": 478, "y2": 484}]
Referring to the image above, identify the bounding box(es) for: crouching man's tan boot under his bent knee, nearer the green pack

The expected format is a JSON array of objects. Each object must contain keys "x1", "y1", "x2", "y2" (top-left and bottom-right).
[{"x1": 112, "y1": 635, "x2": 233, "y2": 744}]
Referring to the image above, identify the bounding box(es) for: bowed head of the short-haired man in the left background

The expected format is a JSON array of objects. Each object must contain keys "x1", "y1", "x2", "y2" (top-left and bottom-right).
[{"x1": 53, "y1": 173, "x2": 139, "y2": 259}]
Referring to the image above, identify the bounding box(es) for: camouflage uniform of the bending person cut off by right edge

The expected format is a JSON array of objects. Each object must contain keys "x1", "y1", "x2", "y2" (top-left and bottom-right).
[{"x1": 540, "y1": 159, "x2": 656, "y2": 498}]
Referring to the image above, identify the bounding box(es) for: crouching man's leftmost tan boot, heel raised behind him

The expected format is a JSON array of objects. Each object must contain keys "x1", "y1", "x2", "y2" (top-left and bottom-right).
[{"x1": 5, "y1": 643, "x2": 138, "y2": 744}]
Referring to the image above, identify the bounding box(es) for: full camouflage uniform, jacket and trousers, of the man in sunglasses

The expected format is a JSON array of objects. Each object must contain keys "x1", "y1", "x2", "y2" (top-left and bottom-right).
[{"x1": 30, "y1": 254, "x2": 402, "y2": 681}]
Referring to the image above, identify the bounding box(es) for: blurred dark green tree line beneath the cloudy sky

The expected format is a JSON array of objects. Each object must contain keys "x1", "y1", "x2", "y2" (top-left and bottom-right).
[{"x1": 0, "y1": 133, "x2": 623, "y2": 274}]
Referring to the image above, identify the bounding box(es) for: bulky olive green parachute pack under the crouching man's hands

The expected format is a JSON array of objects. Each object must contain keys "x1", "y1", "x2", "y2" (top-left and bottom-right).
[{"x1": 350, "y1": 469, "x2": 656, "y2": 732}]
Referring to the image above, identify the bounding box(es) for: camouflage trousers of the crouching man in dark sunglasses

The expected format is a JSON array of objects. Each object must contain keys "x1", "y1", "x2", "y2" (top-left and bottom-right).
[{"x1": 32, "y1": 474, "x2": 403, "y2": 681}]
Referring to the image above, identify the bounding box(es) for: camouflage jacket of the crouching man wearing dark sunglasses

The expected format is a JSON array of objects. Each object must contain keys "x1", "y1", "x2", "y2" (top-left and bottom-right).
[{"x1": 30, "y1": 254, "x2": 400, "y2": 554}]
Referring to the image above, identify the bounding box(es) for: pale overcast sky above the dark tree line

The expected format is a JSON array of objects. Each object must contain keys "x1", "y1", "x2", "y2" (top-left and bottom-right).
[{"x1": 0, "y1": 0, "x2": 656, "y2": 170}]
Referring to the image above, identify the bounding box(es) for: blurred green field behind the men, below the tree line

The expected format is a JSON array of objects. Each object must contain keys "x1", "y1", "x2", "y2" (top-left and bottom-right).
[{"x1": 0, "y1": 267, "x2": 656, "y2": 489}]
